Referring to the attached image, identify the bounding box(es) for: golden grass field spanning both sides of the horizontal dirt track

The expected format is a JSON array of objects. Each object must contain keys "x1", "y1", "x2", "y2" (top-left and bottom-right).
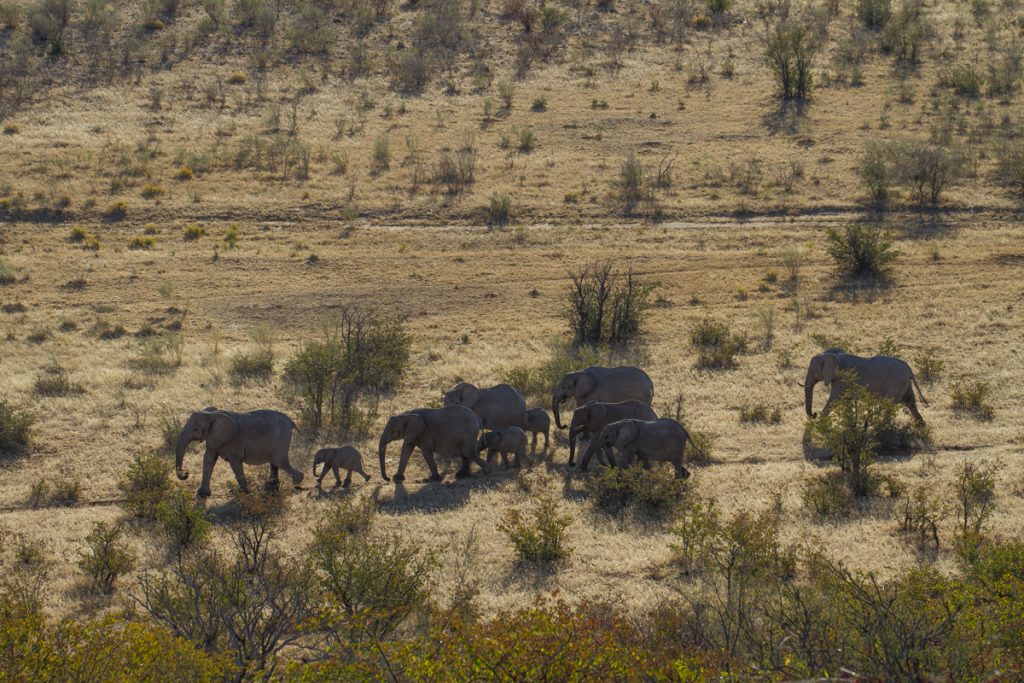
[{"x1": 0, "y1": 0, "x2": 1024, "y2": 626}]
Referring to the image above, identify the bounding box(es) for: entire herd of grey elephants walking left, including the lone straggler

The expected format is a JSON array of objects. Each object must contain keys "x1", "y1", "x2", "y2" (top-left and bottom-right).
[{"x1": 175, "y1": 349, "x2": 927, "y2": 498}]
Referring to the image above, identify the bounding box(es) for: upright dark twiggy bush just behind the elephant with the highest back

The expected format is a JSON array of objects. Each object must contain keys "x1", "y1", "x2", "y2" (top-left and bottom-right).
[{"x1": 564, "y1": 261, "x2": 655, "y2": 346}]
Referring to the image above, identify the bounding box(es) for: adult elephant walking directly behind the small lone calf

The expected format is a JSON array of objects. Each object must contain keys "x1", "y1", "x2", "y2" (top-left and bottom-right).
[{"x1": 379, "y1": 405, "x2": 490, "y2": 481}]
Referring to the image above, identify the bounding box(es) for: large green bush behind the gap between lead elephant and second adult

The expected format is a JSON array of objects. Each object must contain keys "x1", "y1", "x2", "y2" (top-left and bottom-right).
[{"x1": 285, "y1": 307, "x2": 412, "y2": 429}]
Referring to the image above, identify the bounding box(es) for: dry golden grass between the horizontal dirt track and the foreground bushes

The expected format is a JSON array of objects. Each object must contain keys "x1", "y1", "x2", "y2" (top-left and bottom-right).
[{"x1": 0, "y1": 217, "x2": 1024, "y2": 611}]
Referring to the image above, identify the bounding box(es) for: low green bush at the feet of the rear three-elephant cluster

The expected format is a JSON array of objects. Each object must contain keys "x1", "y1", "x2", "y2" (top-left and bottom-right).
[{"x1": 585, "y1": 467, "x2": 686, "y2": 519}]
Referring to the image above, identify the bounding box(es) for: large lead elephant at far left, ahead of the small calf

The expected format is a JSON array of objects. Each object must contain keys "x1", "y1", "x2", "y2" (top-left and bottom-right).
[{"x1": 174, "y1": 408, "x2": 302, "y2": 498}]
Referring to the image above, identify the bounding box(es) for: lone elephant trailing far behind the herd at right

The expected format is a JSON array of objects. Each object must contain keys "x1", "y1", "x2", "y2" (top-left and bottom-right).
[{"x1": 798, "y1": 349, "x2": 928, "y2": 424}]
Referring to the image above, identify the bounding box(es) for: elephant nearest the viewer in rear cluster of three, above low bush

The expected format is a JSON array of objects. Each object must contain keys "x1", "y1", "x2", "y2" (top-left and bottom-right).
[{"x1": 598, "y1": 418, "x2": 703, "y2": 479}]
